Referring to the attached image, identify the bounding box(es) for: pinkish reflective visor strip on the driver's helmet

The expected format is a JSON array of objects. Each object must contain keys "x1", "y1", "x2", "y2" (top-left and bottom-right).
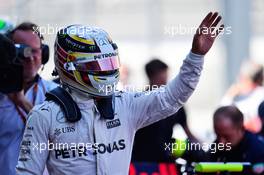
[{"x1": 65, "y1": 56, "x2": 120, "y2": 72}]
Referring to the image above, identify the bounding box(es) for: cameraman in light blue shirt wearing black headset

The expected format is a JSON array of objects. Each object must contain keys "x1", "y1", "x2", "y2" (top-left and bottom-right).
[{"x1": 0, "y1": 22, "x2": 57, "y2": 175}]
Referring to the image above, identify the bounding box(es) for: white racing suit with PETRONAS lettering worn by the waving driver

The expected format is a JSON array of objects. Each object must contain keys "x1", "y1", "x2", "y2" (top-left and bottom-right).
[{"x1": 17, "y1": 53, "x2": 203, "y2": 175}]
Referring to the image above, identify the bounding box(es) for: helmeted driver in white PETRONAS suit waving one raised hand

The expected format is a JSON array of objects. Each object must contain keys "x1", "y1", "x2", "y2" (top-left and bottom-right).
[{"x1": 17, "y1": 13, "x2": 224, "y2": 175}]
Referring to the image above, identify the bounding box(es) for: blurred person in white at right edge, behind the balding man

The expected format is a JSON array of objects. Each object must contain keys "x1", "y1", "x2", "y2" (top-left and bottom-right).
[{"x1": 222, "y1": 60, "x2": 264, "y2": 133}]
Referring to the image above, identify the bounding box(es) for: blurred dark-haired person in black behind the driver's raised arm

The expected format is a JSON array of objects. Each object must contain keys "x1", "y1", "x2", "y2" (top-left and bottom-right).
[{"x1": 132, "y1": 58, "x2": 195, "y2": 162}]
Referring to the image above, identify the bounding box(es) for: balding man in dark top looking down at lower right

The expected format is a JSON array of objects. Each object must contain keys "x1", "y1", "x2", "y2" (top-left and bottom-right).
[{"x1": 210, "y1": 106, "x2": 264, "y2": 164}]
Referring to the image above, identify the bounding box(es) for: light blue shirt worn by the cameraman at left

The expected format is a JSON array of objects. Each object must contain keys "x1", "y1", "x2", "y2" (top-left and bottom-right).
[{"x1": 0, "y1": 77, "x2": 57, "y2": 175}]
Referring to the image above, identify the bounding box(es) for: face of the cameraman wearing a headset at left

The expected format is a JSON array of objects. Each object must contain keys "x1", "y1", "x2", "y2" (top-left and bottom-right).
[{"x1": 13, "y1": 30, "x2": 41, "y2": 82}]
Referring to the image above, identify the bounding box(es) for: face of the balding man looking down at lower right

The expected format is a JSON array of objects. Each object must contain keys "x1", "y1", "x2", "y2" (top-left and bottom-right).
[{"x1": 214, "y1": 117, "x2": 243, "y2": 146}]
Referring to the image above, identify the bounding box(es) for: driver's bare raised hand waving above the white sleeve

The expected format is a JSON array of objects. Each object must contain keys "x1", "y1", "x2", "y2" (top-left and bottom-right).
[{"x1": 191, "y1": 12, "x2": 224, "y2": 55}]
